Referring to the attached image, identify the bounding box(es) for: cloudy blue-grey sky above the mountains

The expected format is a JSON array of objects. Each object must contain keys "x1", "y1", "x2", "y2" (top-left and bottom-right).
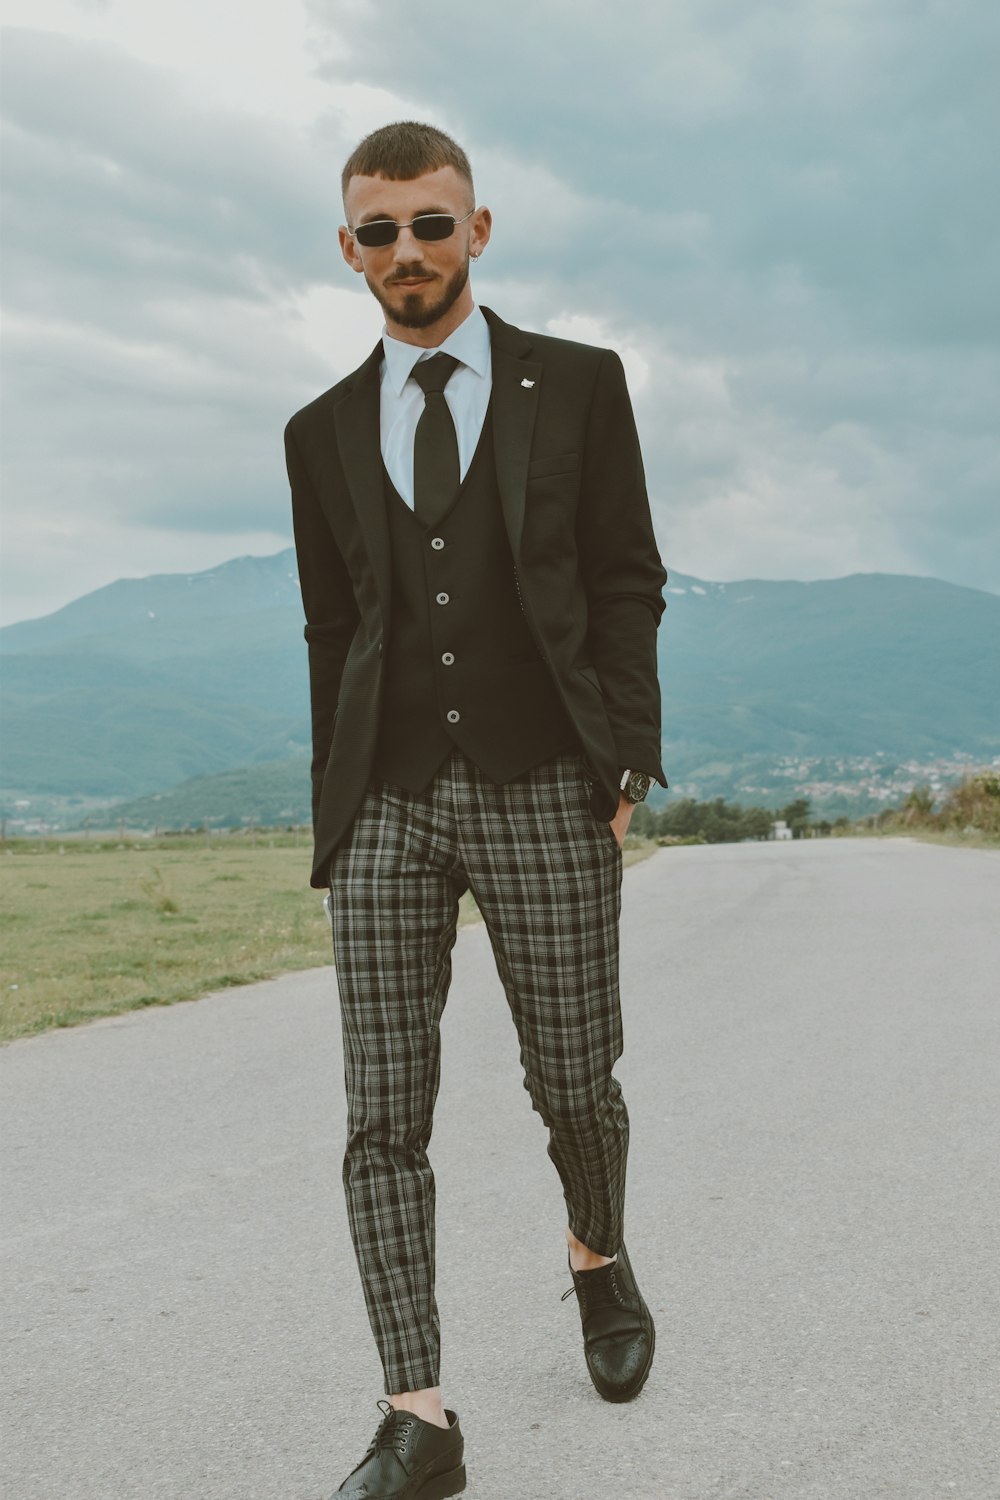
[{"x1": 0, "y1": 0, "x2": 1000, "y2": 621}]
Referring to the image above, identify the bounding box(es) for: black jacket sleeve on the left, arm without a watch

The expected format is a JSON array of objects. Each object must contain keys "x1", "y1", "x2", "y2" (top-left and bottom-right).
[{"x1": 285, "y1": 422, "x2": 360, "y2": 831}]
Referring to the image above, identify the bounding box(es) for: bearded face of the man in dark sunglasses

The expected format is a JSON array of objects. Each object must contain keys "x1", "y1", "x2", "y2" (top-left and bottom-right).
[{"x1": 340, "y1": 167, "x2": 490, "y2": 336}]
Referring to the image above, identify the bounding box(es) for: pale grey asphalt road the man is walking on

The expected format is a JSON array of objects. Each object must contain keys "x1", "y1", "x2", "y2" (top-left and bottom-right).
[{"x1": 0, "y1": 840, "x2": 1000, "y2": 1500}]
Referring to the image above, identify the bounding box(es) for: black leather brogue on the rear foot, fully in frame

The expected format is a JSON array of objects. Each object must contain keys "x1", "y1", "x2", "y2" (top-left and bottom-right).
[{"x1": 562, "y1": 1245, "x2": 657, "y2": 1401}]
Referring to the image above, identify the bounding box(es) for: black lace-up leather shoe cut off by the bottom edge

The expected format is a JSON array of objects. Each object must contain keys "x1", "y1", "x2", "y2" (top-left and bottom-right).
[{"x1": 331, "y1": 1401, "x2": 465, "y2": 1500}]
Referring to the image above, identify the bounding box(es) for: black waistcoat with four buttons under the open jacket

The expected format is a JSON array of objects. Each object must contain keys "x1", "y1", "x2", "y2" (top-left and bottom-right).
[{"x1": 373, "y1": 413, "x2": 580, "y2": 792}]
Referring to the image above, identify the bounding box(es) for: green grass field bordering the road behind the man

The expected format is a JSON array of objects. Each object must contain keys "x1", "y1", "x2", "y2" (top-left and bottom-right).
[{"x1": 0, "y1": 833, "x2": 654, "y2": 1041}]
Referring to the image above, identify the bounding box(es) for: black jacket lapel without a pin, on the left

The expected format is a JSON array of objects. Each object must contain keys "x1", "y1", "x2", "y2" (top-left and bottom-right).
[{"x1": 333, "y1": 341, "x2": 391, "y2": 624}]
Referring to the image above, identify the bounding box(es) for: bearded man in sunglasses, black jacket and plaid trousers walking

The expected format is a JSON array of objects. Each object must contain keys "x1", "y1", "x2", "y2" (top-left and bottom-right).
[{"x1": 285, "y1": 122, "x2": 666, "y2": 1500}]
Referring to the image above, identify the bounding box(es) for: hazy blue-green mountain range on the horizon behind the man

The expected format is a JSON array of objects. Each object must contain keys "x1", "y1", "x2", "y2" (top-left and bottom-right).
[{"x1": 0, "y1": 549, "x2": 1000, "y2": 827}]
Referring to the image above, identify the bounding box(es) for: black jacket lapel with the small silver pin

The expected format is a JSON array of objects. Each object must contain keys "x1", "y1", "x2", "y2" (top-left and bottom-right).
[{"x1": 483, "y1": 308, "x2": 541, "y2": 557}]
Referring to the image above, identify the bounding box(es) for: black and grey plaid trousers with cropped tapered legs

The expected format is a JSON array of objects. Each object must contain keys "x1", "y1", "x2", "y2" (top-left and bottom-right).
[{"x1": 330, "y1": 750, "x2": 628, "y2": 1395}]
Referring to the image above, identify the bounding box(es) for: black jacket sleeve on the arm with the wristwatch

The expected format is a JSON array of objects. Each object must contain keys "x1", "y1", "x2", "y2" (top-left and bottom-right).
[{"x1": 577, "y1": 350, "x2": 667, "y2": 786}]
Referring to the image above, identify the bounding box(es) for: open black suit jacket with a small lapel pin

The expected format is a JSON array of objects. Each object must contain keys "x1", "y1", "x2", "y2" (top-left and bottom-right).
[{"x1": 285, "y1": 308, "x2": 667, "y2": 888}]
